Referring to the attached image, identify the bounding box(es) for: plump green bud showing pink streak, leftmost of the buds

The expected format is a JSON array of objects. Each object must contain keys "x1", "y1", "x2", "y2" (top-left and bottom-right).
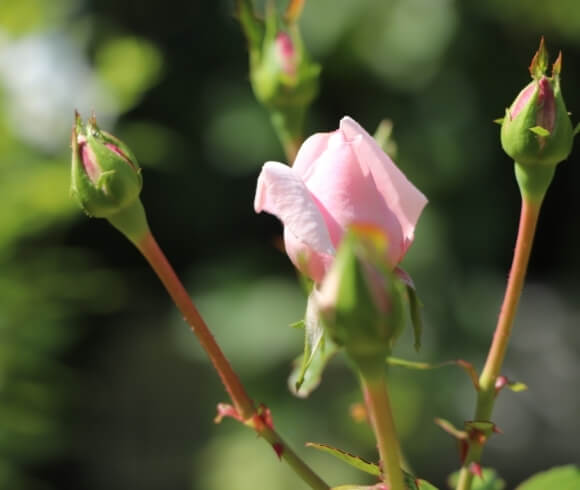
[{"x1": 71, "y1": 113, "x2": 143, "y2": 218}]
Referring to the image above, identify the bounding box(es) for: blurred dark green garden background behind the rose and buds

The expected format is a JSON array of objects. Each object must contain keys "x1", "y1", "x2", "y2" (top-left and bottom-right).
[{"x1": 0, "y1": 0, "x2": 580, "y2": 490}]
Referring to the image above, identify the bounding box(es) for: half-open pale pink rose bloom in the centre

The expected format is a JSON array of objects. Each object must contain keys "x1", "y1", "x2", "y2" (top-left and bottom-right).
[{"x1": 254, "y1": 117, "x2": 427, "y2": 283}]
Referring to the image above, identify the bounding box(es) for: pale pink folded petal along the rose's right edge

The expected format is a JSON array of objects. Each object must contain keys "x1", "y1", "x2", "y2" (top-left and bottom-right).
[{"x1": 340, "y1": 116, "x2": 427, "y2": 253}]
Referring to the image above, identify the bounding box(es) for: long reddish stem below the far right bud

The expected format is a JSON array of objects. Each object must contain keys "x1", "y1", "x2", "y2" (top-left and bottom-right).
[{"x1": 457, "y1": 194, "x2": 543, "y2": 490}]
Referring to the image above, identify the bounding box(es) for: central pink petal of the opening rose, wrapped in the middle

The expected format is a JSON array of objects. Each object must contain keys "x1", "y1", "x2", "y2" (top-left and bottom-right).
[{"x1": 306, "y1": 132, "x2": 403, "y2": 265}]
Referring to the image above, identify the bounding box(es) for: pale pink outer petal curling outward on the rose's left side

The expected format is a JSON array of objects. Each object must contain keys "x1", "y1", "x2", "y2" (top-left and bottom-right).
[{"x1": 254, "y1": 162, "x2": 335, "y2": 281}]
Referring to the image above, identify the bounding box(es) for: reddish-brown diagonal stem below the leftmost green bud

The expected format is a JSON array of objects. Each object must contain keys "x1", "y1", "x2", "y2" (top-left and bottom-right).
[{"x1": 134, "y1": 231, "x2": 330, "y2": 490}]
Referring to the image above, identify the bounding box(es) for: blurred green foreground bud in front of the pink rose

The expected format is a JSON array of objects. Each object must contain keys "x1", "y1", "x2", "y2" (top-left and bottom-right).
[{"x1": 316, "y1": 225, "x2": 405, "y2": 363}]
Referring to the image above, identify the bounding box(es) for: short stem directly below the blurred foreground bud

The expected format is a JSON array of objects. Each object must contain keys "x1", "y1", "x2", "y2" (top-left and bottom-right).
[{"x1": 360, "y1": 362, "x2": 406, "y2": 490}]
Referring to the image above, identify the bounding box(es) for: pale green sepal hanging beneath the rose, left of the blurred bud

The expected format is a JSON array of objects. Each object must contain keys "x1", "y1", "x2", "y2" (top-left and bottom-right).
[{"x1": 288, "y1": 296, "x2": 338, "y2": 398}]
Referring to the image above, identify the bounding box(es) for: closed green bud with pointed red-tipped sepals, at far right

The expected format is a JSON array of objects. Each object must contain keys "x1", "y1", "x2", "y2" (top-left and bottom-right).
[{"x1": 501, "y1": 38, "x2": 574, "y2": 167}]
